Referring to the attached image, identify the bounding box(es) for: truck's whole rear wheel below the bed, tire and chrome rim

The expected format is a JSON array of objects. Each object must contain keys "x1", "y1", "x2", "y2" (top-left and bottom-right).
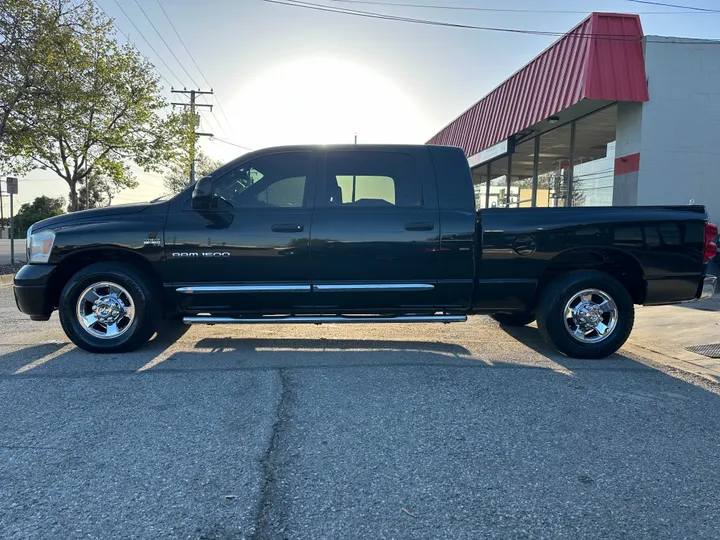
[{"x1": 537, "y1": 270, "x2": 635, "y2": 358}]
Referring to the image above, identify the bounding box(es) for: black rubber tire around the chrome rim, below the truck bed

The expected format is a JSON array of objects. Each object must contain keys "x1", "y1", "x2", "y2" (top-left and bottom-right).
[{"x1": 537, "y1": 270, "x2": 635, "y2": 359}]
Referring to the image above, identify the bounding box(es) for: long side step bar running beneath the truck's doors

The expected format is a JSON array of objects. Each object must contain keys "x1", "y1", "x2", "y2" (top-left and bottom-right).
[{"x1": 183, "y1": 315, "x2": 467, "y2": 324}]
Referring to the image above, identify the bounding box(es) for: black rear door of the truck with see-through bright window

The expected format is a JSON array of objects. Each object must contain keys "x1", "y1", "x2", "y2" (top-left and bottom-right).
[{"x1": 311, "y1": 147, "x2": 440, "y2": 313}]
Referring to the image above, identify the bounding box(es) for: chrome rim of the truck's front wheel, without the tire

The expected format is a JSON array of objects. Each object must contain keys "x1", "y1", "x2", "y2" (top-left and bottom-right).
[{"x1": 76, "y1": 281, "x2": 135, "y2": 339}]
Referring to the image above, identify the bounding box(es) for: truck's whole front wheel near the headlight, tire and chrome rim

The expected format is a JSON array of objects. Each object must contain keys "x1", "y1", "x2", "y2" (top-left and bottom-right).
[{"x1": 59, "y1": 263, "x2": 162, "y2": 353}]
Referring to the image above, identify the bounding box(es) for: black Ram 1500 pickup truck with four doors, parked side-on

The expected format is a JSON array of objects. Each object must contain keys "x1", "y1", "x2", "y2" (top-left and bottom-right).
[{"x1": 15, "y1": 145, "x2": 717, "y2": 358}]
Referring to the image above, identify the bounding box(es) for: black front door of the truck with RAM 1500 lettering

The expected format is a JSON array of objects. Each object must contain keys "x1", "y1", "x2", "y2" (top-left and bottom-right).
[{"x1": 165, "y1": 152, "x2": 317, "y2": 314}]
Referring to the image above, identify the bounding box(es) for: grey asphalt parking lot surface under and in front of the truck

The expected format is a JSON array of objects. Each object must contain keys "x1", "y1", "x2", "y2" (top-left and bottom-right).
[{"x1": 0, "y1": 288, "x2": 720, "y2": 540}]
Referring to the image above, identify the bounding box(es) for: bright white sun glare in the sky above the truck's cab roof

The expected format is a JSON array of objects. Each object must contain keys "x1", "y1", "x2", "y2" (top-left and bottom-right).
[{"x1": 228, "y1": 58, "x2": 429, "y2": 148}]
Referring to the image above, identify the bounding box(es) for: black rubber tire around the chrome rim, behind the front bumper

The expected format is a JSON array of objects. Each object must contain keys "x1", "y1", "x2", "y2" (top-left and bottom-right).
[{"x1": 58, "y1": 262, "x2": 162, "y2": 353}]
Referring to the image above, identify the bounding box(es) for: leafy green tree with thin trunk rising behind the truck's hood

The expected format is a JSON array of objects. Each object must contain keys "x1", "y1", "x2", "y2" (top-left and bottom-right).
[{"x1": 18, "y1": 0, "x2": 182, "y2": 210}]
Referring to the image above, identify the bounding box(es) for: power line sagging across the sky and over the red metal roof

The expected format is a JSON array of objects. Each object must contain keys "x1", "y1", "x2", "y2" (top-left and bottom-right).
[{"x1": 263, "y1": 0, "x2": 720, "y2": 45}]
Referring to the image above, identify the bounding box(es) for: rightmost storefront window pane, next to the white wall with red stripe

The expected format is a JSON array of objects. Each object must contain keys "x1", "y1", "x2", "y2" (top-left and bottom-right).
[{"x1": 572, "y1": 105, "x2": 617, "y2": 206}]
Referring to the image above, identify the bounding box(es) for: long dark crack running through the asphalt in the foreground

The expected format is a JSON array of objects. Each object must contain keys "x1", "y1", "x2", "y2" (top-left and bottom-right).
[{"x1": 252, "y1": 369, "x2": 294, "y2": 540}]
